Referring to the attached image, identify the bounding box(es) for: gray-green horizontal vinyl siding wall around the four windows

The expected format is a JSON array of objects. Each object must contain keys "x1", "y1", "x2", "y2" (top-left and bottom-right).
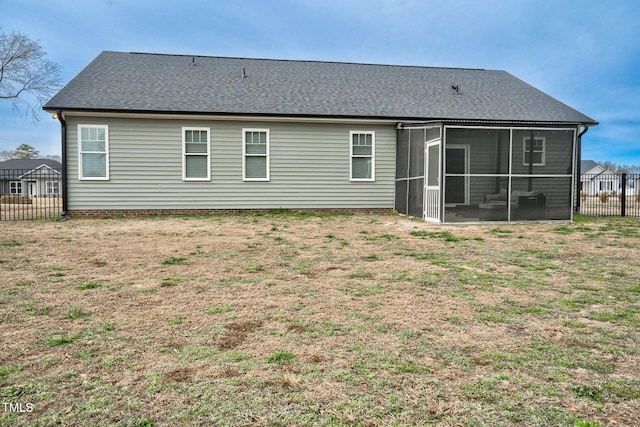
[{"x1": 67, "y1": 117, "x2": 396, "y2": 210}]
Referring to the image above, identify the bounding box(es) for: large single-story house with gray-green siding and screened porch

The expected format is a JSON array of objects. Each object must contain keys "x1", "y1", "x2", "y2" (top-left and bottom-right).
[{"x1": 44, "y1": 52, "x2": 597, "y2": 221}]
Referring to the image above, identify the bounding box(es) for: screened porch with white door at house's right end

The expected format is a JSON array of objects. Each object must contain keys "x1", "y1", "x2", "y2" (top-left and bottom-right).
[{"x1": 395, "y1": 122, "x2": 578, "y2": 223}]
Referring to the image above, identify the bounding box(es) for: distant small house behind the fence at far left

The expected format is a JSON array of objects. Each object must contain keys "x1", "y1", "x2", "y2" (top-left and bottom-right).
[{"x1": 0, "y1": 159, "x2": 62, "y2": 197}]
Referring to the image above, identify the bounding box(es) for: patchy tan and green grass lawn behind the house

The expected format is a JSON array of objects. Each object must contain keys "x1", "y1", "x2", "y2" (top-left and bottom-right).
[{"x1": 0, "y1": 212, "x2": 640, "y2": 427}]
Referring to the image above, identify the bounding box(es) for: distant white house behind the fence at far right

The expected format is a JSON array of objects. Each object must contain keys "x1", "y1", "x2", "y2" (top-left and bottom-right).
[{"x1": 580, "y1": 160, "x2": 638, "y2": 196}]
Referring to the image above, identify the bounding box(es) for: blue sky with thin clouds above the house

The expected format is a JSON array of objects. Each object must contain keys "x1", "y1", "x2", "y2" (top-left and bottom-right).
[{"x1": 0, "y1": 0, "x2": 640, "y2": 165}]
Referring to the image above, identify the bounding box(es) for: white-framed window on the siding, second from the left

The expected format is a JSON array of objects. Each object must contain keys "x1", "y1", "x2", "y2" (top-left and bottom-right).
[{"x1": 182, "y1": 127, "x2": 211, "y2": 181}]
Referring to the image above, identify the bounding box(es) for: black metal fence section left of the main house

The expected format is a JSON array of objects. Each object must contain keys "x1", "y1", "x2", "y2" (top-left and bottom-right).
[{"x1": 0, "y1": 165, "x2": 62, "y2": 221}]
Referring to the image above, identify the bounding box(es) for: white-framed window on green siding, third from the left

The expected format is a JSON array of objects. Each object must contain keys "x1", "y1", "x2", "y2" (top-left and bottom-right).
[{"x1": 242, "y1": 129, "x2": 270, "y2": 181}]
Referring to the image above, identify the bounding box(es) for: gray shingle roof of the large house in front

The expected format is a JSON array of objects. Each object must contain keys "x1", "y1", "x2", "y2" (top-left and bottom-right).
[{"x1": 44, "y1": 51, "x2": 596, "y2": 124}]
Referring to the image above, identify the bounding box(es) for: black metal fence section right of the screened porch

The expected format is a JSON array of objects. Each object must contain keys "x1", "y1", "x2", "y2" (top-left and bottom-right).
[{"x1": 576, "y1": 173, "x2": 640, "y2": 218}]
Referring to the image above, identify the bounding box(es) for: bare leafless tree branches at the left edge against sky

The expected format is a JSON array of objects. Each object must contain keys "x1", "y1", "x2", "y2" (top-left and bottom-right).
[{"x1": 0, "y1": 31, "x2": 61, "y2": 121}]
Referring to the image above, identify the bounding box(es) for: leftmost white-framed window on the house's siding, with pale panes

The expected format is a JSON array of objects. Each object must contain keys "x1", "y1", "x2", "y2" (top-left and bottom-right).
[{"x1": 78, "y1": 125, "x2": 109, "y2": 181}]
